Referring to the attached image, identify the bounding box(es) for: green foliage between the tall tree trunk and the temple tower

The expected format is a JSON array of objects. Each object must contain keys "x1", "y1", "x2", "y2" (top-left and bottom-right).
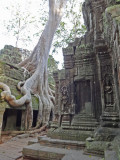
[{"x1": 52, "y1": 0, "x2": 86, "y2": 53}]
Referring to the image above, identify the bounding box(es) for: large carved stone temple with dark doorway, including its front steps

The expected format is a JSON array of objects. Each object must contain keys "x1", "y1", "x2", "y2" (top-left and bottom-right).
[{"x1": 20, "y1": 0, "x2": 120, "y2": 160}]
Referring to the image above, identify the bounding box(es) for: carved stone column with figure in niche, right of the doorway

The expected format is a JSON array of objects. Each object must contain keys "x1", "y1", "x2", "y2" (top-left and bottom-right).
[{"x1": 96, "y1": 44, "x2": 119, "y2": 128}]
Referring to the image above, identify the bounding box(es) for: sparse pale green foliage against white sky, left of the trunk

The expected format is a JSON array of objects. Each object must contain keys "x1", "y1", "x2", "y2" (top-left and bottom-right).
[{"x1": 4, "y1": 3, "x2": 35, "y2": 47}]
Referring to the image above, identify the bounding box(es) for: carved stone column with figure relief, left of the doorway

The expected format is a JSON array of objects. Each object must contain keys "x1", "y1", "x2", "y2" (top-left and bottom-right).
[{"x1": 59, "y1": 46, "x2": 75, "y2": 127}]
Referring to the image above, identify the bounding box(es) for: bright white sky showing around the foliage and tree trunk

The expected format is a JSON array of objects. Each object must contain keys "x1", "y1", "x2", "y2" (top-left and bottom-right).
[{"x1": 0, "y1": 0, "x2": 84, "y2": 69}]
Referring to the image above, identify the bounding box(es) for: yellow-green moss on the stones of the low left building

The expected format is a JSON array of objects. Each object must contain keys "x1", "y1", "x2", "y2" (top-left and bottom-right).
[{"x1": 0, "y1": 53, "x2": 39, "y2": 110}]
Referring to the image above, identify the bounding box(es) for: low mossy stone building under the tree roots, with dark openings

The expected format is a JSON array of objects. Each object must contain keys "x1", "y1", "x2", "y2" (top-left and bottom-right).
[{"x1": 0, "y1": 45, "x2": 38, "y2": 135}]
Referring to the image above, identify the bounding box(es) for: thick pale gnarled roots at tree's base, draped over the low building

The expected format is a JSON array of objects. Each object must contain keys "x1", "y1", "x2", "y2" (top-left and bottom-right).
[{"x1": 0, "y1": 82, "x2": 54, "y2": 130}]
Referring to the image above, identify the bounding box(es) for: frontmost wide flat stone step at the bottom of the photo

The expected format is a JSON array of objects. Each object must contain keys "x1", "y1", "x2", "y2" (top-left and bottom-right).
[{"x1": 23, "y1": 143, "x2": 100, "y2": 160}]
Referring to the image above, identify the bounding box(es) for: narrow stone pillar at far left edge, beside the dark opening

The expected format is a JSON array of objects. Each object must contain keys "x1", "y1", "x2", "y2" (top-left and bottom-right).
[{"x1": 0, "y1": 103, "x2": 5, "y2": 141}]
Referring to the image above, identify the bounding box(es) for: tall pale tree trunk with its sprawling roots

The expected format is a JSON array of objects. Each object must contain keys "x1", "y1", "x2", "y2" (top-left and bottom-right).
[{"x1": 1, "y1": 0, "x2": 67, "y2": 129}]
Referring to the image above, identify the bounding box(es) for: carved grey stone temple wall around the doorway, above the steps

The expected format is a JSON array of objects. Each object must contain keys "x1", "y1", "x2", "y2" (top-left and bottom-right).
[{"x1": 52, "y1": 0, "x2": 120, "y2": 144}]
